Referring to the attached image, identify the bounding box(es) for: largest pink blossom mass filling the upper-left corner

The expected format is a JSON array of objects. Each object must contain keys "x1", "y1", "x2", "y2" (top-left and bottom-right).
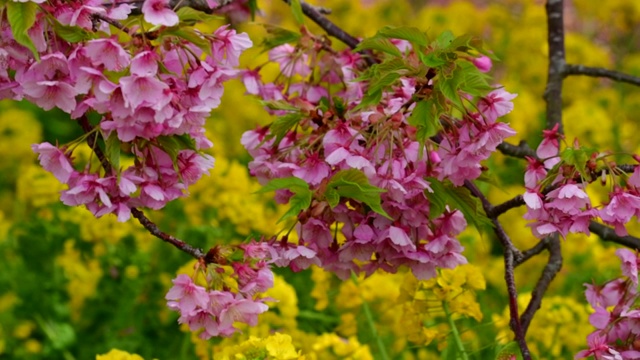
[{"x1": 5, "y1": 0, "x2": 252, "y2": 221}]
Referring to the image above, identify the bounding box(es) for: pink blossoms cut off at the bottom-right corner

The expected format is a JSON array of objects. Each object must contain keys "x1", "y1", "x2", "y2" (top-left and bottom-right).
[{"x1": 575, "y1": 249, "x2": 640, "y2": 360}]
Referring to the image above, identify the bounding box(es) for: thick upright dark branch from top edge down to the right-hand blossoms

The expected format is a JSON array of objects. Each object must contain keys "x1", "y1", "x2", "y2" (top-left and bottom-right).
[{"x1": 544, "y1": 0, "x2": 566, "y2": 134}]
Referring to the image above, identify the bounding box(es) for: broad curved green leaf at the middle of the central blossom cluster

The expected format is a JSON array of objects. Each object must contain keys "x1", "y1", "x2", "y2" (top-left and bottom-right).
[{"x1": 325, "y1": 169, "x2": 393, "y2": 220}]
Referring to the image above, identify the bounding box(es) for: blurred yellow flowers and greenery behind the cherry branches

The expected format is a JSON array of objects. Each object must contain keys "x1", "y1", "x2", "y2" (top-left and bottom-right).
[{"x1": 0, "y1": 0, "x2": 640, "y2": 359}]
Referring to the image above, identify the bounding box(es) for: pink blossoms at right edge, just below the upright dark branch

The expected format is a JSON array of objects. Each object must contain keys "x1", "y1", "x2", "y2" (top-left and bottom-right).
[{"x1": 523, "y1": 126, "x2": 640, "y2": 238}]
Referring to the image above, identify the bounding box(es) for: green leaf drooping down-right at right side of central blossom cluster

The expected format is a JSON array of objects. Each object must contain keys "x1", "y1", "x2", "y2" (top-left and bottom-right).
[{"x1": 425, "y1": 178, "x2": 493, "y2": 229}]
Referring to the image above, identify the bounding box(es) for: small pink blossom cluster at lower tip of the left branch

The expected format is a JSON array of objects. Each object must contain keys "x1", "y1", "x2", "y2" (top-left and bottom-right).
[{"x1": 165, "y1": 243, "x2": 274, "y2": 339}]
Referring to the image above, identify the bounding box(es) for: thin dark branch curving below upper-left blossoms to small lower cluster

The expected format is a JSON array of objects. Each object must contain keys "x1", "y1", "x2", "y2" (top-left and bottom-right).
[{"x1": 79, "y1": 115, "x2": 205, "y2": 259}]
